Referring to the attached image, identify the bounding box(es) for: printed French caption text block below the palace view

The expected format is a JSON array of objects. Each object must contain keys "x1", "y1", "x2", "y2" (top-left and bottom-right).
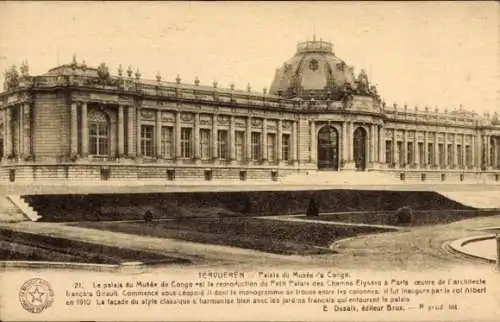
[{"x1": 65, "y1": 270, "x2": 488, "y2": 312}]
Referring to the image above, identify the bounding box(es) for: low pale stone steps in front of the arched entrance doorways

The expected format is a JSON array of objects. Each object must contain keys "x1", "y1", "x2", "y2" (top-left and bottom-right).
[{"x1": 280, "y1": 171, "x2": 401, "y2": 185}]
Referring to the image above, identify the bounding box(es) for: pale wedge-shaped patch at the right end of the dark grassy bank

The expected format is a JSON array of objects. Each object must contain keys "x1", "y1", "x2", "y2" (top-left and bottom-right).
[{"x1": 437, "y1": 190, "x2": 500, "y2": 210}]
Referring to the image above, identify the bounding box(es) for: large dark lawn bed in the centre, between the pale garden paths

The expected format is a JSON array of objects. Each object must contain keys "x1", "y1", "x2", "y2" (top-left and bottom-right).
[{"x1": 71, "y1": 217, "x2": 385, "y2": 255}]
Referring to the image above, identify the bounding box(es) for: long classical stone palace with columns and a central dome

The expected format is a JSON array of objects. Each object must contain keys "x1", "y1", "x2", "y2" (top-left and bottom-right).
[{"x1": 0, "y1": 40, "x2": 500, "y2": 182}]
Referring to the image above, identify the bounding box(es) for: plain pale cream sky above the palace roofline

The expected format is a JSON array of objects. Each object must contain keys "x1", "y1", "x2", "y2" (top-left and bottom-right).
[{"x1": 0, "y1": 1, "x2": 500, "y2": 114}]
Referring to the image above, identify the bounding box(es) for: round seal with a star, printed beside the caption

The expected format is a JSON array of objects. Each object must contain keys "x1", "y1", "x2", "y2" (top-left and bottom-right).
[{"x1": 19, "y1": 278, "x2": 54, "y2": 313}]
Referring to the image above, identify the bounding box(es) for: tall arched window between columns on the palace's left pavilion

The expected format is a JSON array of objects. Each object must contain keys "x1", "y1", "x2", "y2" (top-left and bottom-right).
[{"x1": 88, "y1": 110, "x2": 110, "y2": 156}]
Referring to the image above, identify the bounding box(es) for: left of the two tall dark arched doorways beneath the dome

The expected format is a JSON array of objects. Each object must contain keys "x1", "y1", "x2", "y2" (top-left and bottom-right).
[{"x1": 318, "y1": 126, "x2": 339, "y2": 171}]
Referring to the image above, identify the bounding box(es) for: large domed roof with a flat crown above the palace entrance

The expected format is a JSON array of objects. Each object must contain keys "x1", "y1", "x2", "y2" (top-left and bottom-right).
[{"x1": 270, "y1": 39, "x2": 357, "y2": 99}]
